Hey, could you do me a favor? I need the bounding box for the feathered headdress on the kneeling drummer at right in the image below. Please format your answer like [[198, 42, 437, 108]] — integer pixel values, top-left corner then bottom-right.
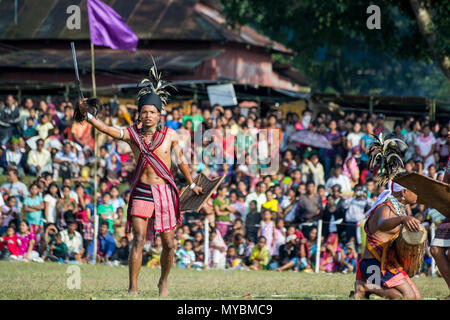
[[369, 133, 408, 185]]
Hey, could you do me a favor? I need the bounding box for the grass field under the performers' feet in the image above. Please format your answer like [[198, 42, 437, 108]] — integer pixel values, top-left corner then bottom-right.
[[0, 262, 448, 300]]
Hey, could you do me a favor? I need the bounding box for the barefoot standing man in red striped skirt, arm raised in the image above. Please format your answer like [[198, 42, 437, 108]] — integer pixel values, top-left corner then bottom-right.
[[79, 66, 202, 296]]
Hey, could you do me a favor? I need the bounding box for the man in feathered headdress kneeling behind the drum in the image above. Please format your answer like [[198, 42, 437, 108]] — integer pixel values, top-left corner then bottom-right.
[[351, 134, 421, 299]]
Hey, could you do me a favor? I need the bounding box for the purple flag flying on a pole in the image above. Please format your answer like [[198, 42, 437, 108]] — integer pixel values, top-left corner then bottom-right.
[[87, 0, 138, 51]]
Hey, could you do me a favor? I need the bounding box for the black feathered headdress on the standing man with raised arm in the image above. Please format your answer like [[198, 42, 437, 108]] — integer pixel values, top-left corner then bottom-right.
[[137, 56, 176, 112]]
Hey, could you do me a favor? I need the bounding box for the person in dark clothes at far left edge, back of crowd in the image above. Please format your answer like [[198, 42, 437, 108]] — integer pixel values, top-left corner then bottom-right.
[[0, 94, 20, 146]]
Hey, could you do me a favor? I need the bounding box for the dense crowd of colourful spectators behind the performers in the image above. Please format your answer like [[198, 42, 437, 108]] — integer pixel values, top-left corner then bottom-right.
[[0, 95, 450, 274]]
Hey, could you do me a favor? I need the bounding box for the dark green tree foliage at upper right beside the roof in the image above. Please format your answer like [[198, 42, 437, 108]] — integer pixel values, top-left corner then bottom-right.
[[221, 0, 450, 100]]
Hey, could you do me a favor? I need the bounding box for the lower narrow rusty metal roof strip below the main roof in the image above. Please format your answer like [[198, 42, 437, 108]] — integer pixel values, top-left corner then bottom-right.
[[0, 49, 222, 71]]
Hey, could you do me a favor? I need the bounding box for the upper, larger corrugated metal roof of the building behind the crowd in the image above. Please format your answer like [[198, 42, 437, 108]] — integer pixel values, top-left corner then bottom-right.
[[0, 0, 291, 53]]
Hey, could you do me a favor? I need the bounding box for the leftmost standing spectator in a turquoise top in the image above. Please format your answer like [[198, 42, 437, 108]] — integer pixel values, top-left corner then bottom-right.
[[23, 183, 45, 243]]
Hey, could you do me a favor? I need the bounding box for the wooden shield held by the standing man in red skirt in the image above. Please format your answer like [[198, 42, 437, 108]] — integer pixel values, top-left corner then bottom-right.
[[180, 173, 225, 213]]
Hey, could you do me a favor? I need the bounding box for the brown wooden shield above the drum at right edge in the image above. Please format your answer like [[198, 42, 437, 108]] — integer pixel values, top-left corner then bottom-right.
[[394, 172, 450, 218]]
